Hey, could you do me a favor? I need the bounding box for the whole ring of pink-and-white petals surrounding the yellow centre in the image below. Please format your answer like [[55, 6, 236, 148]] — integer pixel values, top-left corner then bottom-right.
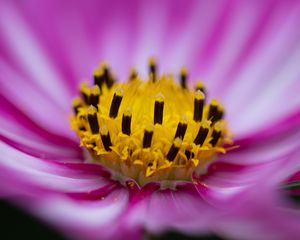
[[0, 1, 300, 239]]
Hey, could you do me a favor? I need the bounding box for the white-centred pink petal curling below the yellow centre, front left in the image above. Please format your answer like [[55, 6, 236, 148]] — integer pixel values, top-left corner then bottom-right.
[[20, 187, 131, 239]]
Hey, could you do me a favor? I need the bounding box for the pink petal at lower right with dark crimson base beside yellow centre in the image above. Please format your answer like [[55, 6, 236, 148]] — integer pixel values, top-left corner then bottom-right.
[[193, 145, 300, 209]]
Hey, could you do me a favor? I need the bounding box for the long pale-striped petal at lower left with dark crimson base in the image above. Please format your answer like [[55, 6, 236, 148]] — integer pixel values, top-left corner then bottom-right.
[[0, 142, 117, 199]]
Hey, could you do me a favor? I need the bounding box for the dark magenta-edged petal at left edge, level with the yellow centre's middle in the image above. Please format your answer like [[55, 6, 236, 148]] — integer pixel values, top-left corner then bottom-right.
[[0, 94, 81, 159]]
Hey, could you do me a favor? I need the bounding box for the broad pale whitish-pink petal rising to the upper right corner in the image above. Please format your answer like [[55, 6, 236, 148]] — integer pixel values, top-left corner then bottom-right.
[[218, 2, 300, 134]]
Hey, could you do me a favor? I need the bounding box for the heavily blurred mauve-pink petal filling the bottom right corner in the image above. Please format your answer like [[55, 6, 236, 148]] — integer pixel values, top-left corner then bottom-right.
[[214, 183, 300, 240]]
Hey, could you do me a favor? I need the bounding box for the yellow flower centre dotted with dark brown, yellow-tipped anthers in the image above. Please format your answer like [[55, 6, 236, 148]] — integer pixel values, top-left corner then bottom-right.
[[71, 59, 231, 185]]
